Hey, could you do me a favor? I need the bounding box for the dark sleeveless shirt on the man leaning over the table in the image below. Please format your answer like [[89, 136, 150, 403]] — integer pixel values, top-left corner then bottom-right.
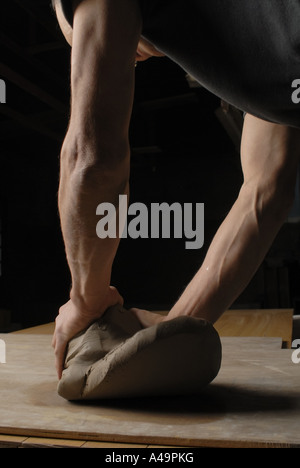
[[55, 0, 300, 127]]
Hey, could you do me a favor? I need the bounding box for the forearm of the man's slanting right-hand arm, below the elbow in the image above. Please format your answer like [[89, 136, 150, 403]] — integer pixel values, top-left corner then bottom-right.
[[170, 181, 290, 323]]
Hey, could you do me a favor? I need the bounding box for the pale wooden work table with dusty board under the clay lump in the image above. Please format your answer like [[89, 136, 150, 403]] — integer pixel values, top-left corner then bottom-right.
[[0, 310, 300, 449]]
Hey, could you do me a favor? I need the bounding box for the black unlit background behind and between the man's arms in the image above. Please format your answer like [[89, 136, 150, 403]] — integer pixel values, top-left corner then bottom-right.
[[0, 0, 300, 331]]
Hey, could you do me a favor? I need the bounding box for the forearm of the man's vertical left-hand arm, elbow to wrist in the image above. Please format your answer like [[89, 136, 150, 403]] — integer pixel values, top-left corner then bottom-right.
[[59, 140, 129, 313]]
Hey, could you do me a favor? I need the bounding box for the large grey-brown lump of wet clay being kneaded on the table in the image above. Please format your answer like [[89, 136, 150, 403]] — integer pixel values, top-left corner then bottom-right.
[[58, 306, 222, 400]]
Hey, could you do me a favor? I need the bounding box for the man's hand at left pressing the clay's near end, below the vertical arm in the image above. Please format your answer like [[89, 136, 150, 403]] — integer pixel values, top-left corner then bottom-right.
[[52, 286, 124, 379]]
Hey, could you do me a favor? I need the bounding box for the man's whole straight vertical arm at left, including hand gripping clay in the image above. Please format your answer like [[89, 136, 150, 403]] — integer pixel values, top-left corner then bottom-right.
[[53, 0, 141, 377]]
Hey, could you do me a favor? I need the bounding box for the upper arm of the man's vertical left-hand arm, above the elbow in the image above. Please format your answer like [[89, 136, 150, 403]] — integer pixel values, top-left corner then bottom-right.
[[63, 0, 142, 145]]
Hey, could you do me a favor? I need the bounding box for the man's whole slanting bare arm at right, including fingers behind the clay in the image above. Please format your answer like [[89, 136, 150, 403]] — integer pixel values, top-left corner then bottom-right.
[[135, 115, 300, 326]]
